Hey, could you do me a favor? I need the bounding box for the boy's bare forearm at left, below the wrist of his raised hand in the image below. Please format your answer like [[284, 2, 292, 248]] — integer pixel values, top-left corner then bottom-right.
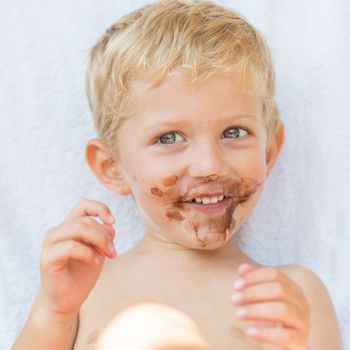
[[12, 290, 78, 350]]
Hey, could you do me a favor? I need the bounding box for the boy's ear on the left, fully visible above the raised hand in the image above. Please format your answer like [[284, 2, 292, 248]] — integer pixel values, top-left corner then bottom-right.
[[85, 139, 131, 196]]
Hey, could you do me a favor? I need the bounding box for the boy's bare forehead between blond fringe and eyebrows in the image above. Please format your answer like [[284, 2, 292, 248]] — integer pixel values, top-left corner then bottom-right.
[[123, 73, 262, 123]]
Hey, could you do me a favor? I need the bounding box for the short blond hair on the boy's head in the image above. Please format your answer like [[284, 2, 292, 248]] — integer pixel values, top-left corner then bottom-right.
[[86, 0, 279, 150]]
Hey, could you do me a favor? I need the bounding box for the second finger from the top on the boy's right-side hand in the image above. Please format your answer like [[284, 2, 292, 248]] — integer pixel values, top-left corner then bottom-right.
[[232, 282, 300, 305]]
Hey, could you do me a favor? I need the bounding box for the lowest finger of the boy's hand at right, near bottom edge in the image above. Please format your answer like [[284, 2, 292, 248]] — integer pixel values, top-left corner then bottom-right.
[[247, 327, 307, 349]]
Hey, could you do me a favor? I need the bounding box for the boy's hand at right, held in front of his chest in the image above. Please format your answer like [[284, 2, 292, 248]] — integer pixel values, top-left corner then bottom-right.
[[232, 263, 310, 350]]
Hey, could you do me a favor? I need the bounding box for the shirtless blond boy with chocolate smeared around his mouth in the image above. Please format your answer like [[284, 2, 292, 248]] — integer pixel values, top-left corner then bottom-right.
[[14, 0, 342, 350]]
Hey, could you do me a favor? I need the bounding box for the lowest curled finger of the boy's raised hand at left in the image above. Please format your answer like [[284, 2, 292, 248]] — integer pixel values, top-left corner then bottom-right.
[[41, 240, 103, 270]]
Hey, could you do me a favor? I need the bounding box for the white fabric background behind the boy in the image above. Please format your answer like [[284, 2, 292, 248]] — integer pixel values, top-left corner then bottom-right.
[[0, 0, 350, 349]]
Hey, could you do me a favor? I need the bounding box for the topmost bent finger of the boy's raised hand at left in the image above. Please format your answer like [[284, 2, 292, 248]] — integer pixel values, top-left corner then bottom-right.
[[62, 199, 115, 224]]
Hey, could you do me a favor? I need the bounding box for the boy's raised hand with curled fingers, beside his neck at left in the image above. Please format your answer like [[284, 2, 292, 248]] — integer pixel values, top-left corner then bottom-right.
[[40, 200, 116, 316]]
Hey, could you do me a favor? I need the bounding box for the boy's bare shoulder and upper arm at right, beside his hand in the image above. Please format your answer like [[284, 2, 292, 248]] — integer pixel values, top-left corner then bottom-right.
[[280, 265, 343, 350]]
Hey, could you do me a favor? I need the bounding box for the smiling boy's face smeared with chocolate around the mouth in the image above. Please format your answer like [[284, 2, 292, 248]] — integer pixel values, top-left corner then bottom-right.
[[118, 73, 267, 249]]
